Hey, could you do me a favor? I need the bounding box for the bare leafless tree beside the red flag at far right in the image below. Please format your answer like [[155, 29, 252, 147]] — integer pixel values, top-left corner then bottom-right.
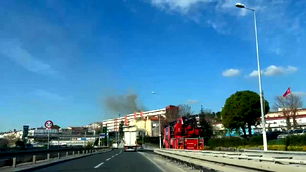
[[274, 93, 303, 130]]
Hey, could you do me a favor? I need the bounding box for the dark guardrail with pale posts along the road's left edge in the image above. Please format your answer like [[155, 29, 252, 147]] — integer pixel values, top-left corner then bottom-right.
[[0, 147, 107, 171]]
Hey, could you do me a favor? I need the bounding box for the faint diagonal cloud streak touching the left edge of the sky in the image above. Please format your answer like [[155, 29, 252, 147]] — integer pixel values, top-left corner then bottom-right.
[[0, 39, 58, 76]]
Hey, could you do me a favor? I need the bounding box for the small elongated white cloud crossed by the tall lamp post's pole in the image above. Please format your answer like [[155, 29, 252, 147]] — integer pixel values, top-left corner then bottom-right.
[[249, 65, 298, 77]]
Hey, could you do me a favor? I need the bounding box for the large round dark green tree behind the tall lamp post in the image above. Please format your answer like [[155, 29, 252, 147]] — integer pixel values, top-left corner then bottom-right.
[[221, 91, 270, 137]]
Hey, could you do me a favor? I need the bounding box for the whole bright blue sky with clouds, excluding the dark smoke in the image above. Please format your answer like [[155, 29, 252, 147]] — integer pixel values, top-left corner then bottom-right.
[[0, 0, 306, 131]]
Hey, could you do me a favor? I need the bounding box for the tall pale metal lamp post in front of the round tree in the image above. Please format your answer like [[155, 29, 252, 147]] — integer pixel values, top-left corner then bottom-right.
[[235, 3, 268, 151]]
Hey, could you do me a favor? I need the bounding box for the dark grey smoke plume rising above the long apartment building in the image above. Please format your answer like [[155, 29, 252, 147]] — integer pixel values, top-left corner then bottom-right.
[[104, 94, 144, 114]]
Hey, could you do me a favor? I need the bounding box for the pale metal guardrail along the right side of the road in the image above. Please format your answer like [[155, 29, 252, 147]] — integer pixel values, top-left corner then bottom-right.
[[154, 149, 306, 172]]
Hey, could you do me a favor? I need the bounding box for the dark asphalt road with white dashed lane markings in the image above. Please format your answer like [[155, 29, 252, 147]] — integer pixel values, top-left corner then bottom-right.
[[31, 149, 161, 172]]
